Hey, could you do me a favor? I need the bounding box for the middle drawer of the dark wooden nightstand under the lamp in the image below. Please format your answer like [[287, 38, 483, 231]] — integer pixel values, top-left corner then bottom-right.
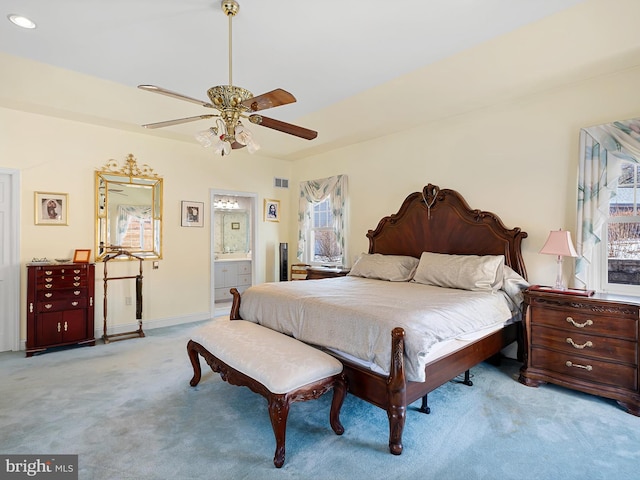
[[531, 325, 638, 365]]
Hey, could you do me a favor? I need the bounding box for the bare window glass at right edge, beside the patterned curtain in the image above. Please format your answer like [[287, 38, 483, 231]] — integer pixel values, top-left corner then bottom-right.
[[602, 162, 640, 291]]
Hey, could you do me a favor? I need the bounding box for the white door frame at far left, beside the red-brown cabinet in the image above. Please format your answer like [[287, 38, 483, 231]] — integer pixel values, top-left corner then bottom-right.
[[0, 167, 20, 351]]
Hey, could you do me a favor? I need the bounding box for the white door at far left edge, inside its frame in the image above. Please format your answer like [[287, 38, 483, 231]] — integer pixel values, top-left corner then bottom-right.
[[0, 170, 20, 352]]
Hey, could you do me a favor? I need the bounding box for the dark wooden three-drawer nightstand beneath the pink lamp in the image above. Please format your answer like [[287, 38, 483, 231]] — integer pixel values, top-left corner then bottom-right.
[[519, 287, 640, 416]]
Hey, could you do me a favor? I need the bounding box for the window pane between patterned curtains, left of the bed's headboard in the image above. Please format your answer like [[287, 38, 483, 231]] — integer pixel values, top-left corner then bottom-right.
[[309, 197, 342, 265]]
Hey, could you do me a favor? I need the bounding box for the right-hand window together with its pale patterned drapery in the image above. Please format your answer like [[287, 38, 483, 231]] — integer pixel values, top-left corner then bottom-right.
[[575, 118, 640, 295]]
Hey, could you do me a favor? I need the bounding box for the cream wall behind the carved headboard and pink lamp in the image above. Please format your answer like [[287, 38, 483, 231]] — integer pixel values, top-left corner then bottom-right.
[[289, 67, 640, 284]]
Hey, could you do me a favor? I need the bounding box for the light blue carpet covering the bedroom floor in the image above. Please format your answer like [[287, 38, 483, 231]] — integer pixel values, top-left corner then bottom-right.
[[0, 318, 640, 480]]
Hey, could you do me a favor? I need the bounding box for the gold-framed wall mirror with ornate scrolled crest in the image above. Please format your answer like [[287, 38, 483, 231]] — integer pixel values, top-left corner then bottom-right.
[[95, 154, 162, 261]]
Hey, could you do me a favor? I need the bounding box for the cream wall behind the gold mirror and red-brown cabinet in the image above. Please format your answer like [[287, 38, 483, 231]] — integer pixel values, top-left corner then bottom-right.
[[0, 108, 291, 342]]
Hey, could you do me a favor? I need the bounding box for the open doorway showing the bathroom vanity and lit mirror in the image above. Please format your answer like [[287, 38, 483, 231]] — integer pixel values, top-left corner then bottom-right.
[[210, 189, 258, 316]]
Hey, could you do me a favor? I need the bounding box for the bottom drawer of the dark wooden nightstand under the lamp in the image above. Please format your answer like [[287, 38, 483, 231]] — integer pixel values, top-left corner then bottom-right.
[[531, 348, 638, 390]]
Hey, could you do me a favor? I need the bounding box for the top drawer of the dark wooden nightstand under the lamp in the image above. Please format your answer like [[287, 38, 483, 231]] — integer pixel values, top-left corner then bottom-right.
[[531, 304, 638, 340]]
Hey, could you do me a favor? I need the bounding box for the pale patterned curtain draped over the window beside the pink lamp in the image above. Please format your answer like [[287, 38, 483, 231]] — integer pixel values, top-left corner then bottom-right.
[[575, 118, 640, 288]]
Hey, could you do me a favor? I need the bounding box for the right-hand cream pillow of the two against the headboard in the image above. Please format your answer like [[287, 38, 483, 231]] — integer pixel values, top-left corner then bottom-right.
[[413, 252, 504, 291]]
